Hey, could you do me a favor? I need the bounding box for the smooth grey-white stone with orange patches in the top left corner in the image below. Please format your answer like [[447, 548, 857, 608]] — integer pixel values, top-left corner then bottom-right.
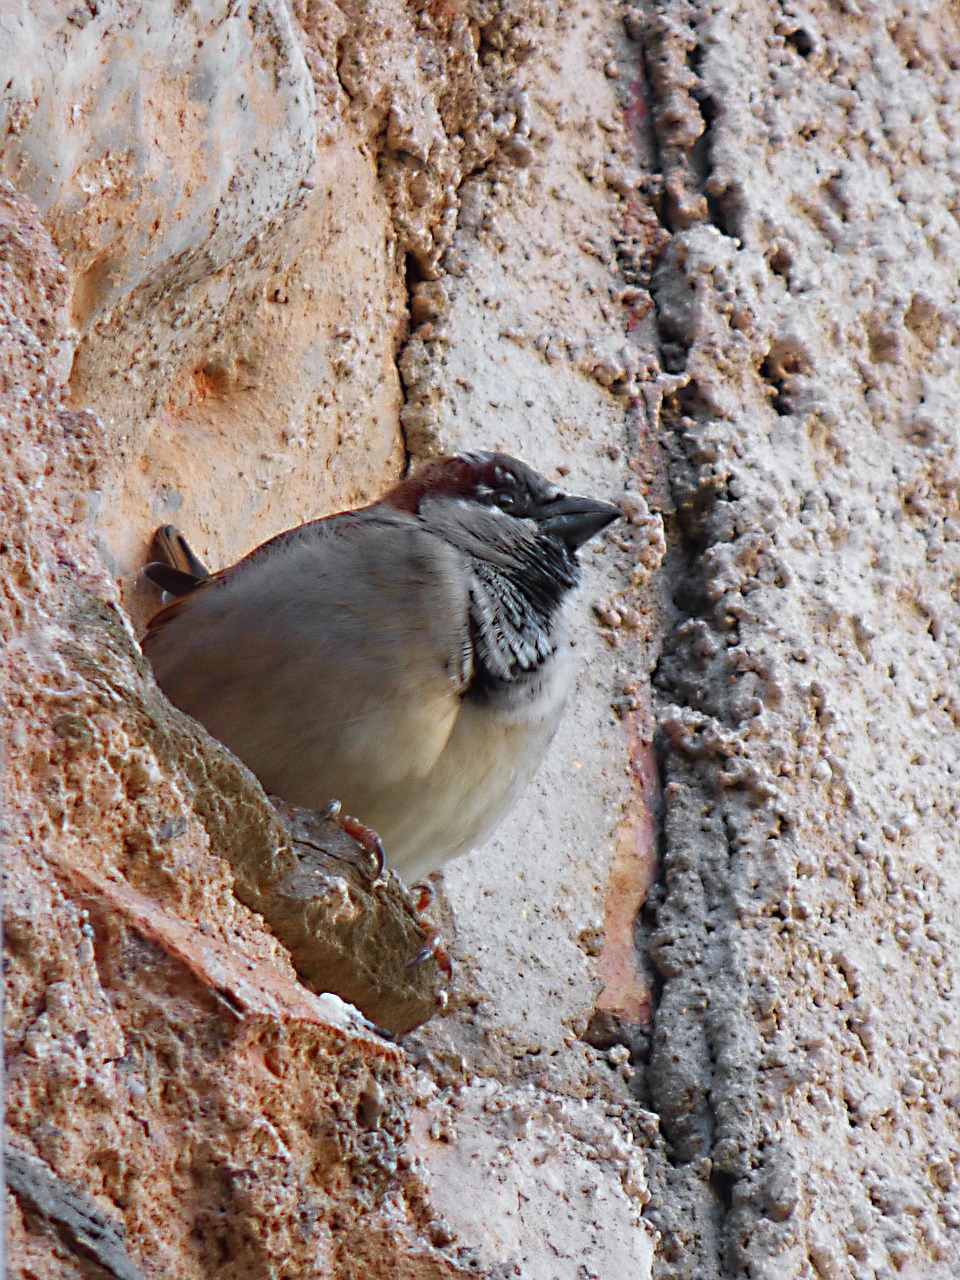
[[0, 0, 316, 329]]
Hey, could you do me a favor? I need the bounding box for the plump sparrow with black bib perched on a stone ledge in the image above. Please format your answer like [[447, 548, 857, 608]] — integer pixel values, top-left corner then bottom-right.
[[143, 453, 622, 884]]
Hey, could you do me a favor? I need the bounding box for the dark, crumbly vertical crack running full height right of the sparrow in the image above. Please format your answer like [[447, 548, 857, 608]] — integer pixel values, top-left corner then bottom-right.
[[635, 5, 777, 1280]]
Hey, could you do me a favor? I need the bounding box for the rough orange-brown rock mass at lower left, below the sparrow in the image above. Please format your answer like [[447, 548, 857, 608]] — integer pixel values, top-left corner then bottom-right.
[[0, 177, 456, 1276]]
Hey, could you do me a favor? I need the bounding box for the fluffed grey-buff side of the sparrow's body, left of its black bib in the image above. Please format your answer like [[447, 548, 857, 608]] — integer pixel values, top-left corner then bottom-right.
[[143, 512, 472, 804]]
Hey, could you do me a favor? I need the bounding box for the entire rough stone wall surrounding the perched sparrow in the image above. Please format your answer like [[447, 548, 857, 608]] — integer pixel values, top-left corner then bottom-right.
[[0, 0, 960, 1280]]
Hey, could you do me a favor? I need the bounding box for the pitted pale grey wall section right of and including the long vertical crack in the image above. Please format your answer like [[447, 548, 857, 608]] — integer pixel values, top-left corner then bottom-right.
[[640, 3, 960, 1280]]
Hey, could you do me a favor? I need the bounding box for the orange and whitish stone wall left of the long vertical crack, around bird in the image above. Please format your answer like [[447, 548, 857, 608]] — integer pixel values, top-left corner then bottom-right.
[[0, 0, 663, 1280]]
